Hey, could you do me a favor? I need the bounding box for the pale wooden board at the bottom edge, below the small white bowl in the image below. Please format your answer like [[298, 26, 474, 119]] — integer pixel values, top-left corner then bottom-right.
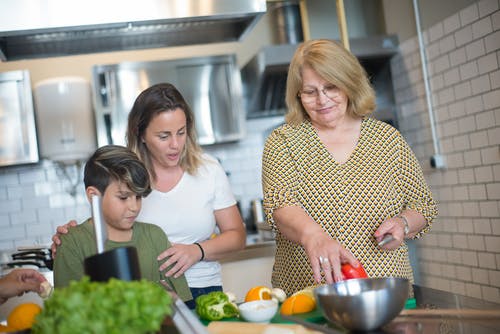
[[207, 321, 319, 334]]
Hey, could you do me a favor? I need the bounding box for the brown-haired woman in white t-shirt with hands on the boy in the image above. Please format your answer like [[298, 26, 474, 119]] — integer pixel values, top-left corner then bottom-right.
[[52, 83, 246, 307]]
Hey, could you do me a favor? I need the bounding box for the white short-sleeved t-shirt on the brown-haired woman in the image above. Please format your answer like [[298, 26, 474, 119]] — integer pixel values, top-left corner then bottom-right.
[[137, 154, 236, 288]]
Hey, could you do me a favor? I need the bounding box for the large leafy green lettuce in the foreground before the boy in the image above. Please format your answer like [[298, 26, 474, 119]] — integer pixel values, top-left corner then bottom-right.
[[31, 277, 172, 334]]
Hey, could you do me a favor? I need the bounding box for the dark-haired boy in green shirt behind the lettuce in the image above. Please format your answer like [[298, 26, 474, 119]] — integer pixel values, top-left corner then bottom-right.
[[54, 145, 192, 301]]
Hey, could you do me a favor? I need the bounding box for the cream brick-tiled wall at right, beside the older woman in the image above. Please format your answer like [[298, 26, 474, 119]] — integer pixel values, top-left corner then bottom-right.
[[392, 0, 500, 303]]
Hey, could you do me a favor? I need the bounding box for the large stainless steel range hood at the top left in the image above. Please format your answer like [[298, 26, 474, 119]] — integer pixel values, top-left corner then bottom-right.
[[0, 0, 266, 61]]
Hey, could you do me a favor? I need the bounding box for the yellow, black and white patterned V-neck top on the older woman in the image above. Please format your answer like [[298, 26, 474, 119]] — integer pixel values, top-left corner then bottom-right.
[[262, 117, 437, 295]]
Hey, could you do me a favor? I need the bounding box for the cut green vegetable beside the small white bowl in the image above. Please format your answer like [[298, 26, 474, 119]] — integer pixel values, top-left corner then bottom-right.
[[195, 291, 239, 321]]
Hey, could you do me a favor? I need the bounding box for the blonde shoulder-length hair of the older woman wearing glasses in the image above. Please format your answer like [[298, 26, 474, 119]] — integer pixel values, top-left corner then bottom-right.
[[285, 39, 376, 125]]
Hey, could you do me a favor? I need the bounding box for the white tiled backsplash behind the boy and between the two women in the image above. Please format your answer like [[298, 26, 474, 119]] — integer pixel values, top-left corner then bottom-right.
[[0, 117, 283, 249]]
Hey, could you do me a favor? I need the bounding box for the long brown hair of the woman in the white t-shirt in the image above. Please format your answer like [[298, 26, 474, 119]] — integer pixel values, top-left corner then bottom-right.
[[127, 83, 202, 180]]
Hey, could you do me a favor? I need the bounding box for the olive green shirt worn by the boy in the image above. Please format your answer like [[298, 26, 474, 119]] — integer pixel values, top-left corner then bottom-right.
[[54, 219, 192, 301]]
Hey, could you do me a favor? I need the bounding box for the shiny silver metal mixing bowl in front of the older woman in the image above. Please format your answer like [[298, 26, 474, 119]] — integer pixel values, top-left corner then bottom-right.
[[314, 277, 410, 331]]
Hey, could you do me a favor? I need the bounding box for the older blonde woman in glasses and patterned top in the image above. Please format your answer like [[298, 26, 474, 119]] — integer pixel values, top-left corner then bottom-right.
[[262, 40, 437, 294]]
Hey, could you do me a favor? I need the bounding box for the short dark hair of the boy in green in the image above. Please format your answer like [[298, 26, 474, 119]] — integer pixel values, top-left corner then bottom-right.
[[83, 145, 151, 197]]
